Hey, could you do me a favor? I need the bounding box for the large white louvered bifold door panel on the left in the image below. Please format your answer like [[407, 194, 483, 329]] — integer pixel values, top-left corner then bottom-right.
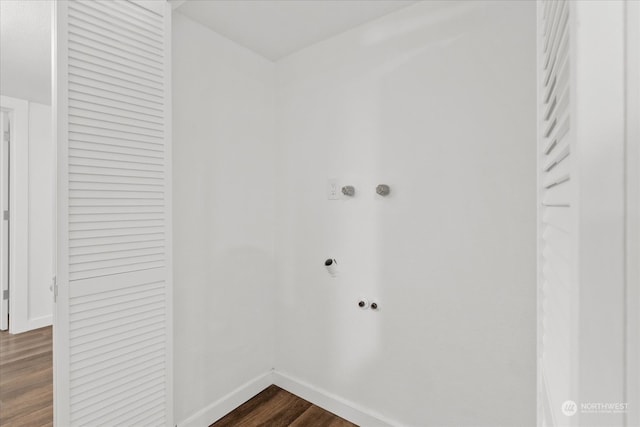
[[54, 0, 173, 426]]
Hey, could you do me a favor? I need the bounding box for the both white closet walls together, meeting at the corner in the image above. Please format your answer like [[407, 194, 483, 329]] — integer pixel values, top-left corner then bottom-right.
[[173, 2, 536, 426]]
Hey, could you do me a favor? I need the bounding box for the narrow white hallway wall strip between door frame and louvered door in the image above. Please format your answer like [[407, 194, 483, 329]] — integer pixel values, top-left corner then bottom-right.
[[28, 102, 55, 327]]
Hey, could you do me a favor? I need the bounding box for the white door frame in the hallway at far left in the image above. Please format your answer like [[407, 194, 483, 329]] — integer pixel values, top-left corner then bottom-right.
[[0, 96, 30, 334]]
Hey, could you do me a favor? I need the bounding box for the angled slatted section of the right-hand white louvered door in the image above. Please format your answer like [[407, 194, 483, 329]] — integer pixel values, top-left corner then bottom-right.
[[538, 0, 575, 424]]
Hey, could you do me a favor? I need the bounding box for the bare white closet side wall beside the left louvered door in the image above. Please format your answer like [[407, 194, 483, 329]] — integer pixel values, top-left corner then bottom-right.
[[173, 12, 275, 423]]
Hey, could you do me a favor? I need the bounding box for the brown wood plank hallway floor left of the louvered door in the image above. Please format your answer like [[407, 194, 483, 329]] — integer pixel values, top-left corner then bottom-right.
[[0, 327, 53, 427]]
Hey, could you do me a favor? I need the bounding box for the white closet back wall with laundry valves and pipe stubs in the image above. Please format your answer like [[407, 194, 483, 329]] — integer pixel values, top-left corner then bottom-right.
[[275, 1, 536, 426]]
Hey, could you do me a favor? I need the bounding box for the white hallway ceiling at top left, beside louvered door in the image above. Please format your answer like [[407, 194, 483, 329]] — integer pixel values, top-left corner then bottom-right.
[[0, 0, 51, 104]]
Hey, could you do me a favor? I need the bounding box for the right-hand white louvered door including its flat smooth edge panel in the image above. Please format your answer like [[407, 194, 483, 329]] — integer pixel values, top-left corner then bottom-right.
[[537, 0, 633, 427]]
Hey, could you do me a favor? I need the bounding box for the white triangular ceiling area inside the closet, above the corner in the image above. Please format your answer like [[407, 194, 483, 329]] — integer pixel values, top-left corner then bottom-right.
[[172, 0, 417, 61]]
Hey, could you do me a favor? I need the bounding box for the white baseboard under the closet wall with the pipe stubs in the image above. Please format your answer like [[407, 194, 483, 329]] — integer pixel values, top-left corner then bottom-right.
[[273, 371, 402, 427]]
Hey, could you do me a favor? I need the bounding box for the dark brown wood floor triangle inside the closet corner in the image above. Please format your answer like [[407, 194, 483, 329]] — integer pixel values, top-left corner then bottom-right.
[[209, 385, 357, 427]]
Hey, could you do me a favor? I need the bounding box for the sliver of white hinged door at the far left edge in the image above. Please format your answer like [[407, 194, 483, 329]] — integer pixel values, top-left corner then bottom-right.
[[0, 111, 11, 331]]
